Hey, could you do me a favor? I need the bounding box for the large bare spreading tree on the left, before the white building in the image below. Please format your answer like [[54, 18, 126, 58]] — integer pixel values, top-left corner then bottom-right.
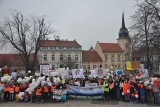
[[0, 12, 52, 73]]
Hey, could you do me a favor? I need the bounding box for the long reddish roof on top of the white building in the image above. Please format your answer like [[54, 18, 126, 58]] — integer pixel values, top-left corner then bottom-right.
[[42, 40, 81, 47]]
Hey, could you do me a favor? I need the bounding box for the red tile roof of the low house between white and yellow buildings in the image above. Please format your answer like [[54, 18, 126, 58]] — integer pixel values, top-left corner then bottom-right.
[[82, 50, 102, 62]]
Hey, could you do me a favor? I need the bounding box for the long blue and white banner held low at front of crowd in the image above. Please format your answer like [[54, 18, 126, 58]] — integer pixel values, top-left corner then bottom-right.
[[67, 85, 104, 95]]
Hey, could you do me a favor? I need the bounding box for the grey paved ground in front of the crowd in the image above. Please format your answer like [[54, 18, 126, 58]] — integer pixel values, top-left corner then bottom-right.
[[0, 99, 160, 107]]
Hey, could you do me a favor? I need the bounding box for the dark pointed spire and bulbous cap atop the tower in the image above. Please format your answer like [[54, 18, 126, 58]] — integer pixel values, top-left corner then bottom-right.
[[119, 12, 129, 38]]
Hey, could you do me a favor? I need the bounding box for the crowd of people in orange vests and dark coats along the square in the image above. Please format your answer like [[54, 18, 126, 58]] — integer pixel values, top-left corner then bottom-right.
[[0, 70, 160, 104]]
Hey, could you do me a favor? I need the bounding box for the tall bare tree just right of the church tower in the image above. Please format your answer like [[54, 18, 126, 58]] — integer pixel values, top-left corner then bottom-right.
[[131, 2, 155, 69]]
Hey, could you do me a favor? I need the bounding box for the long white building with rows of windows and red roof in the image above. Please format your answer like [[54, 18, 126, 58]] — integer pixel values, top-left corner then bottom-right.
[[38, 40, 82, 70]]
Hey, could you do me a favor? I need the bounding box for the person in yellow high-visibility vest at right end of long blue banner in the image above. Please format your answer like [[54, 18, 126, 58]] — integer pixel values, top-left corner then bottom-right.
[[103, 78, 109, 101]]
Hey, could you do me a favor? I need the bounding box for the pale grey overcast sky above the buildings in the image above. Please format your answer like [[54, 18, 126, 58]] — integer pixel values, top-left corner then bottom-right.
[[0, 0, 136, 50]]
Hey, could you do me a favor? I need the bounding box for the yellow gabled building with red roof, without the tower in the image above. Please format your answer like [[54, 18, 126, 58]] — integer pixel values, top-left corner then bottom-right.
[[95, 42, 123, 69]]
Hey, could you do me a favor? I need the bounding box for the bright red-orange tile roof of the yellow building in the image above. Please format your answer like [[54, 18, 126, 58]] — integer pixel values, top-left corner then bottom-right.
[[99, 43, 123, 52]]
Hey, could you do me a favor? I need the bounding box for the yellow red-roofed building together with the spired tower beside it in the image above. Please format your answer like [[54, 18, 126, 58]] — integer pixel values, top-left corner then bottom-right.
[[95, 13, 131, 70]]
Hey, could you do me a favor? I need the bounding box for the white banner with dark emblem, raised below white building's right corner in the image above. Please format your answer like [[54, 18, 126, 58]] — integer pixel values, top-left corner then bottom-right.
[[72, 69, 84, 78]]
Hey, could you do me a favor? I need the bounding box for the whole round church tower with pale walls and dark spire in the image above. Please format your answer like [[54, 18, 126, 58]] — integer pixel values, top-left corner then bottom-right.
[[117, 12, 131, 60]]
